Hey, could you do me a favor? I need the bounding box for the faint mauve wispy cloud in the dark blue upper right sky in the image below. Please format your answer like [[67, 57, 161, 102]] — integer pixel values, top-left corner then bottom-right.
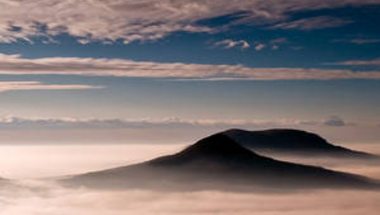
[[271, 16, 352, 30]]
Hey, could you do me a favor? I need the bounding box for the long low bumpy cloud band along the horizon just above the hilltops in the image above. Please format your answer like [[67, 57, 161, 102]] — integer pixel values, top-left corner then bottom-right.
[[0, 116, 360, 129]]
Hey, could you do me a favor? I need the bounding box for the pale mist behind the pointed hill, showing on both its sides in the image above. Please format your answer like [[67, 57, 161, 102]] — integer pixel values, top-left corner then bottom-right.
[[0, 141, 380, 179]]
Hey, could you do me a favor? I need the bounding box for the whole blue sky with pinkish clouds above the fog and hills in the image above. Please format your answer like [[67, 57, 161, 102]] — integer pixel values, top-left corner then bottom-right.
[[0, 0, 380, 144]]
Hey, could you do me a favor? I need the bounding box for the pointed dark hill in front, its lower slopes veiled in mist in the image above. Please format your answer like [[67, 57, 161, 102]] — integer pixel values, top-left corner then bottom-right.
[[64, 133, 379, 191]]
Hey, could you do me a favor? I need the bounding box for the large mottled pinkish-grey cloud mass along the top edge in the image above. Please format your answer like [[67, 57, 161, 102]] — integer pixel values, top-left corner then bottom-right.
[[0, 0, 380, 43]]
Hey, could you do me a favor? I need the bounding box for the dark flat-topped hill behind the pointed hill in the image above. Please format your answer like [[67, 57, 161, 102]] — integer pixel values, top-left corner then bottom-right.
[[222, 129, 380, 160]]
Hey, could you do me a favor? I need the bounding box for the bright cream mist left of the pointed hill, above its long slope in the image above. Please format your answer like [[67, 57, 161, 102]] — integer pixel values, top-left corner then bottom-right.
[[0, 144, 185, 179]]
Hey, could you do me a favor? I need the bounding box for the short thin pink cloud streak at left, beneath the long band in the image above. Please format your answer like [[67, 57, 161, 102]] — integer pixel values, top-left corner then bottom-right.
[[0, 81, 102, 93]]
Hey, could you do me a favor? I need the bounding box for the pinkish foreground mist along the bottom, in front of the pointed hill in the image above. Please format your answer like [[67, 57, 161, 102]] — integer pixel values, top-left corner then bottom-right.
[[0, 182, 380, 215]]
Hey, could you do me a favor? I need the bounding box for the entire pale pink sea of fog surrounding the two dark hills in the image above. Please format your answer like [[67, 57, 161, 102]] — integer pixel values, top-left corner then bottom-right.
[[0, 144, 380, 215]]
